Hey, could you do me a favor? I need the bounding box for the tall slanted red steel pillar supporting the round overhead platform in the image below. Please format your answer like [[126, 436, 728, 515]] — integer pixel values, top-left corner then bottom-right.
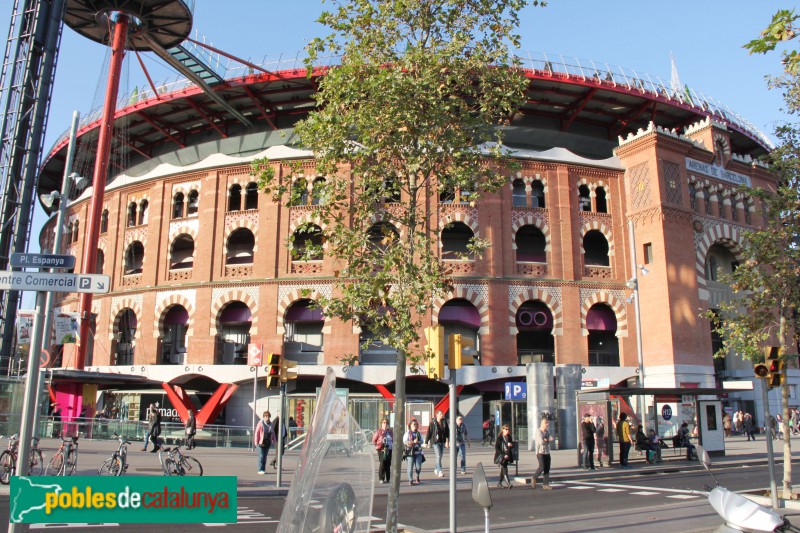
[[75, 13, 129, 370]]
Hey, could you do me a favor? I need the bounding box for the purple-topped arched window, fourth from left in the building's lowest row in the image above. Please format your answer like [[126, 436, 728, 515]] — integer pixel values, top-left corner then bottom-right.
[[283, 299, 325, 365]]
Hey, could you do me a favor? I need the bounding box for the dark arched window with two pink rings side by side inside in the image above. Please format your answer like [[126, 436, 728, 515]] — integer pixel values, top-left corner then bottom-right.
[[516, 300, 556, 365]]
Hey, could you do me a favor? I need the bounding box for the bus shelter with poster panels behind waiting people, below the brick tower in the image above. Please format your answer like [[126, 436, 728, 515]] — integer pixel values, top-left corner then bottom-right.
[[575, 387, 727, 464]]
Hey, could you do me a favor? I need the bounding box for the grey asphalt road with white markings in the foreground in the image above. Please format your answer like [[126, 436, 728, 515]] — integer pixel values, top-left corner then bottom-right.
[[0, 465, 788, 533]]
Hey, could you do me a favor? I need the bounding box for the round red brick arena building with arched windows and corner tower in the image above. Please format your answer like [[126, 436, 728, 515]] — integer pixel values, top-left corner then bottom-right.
[[40, 58, 774, 432]]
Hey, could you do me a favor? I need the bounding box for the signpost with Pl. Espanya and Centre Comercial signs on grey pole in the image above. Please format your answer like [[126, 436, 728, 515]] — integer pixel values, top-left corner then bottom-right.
[[10, 254, 111, 494]]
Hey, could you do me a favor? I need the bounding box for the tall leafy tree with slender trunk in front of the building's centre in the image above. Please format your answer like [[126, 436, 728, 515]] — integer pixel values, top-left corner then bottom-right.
[[254, 0, 540, 531]]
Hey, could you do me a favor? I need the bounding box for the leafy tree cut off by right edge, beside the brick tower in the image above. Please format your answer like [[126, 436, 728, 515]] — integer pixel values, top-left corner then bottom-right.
[[707, 10, 800, 497]]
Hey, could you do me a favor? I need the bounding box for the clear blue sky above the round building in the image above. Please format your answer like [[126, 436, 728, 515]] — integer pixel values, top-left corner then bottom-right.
[[0, 0, 787, 264]]
